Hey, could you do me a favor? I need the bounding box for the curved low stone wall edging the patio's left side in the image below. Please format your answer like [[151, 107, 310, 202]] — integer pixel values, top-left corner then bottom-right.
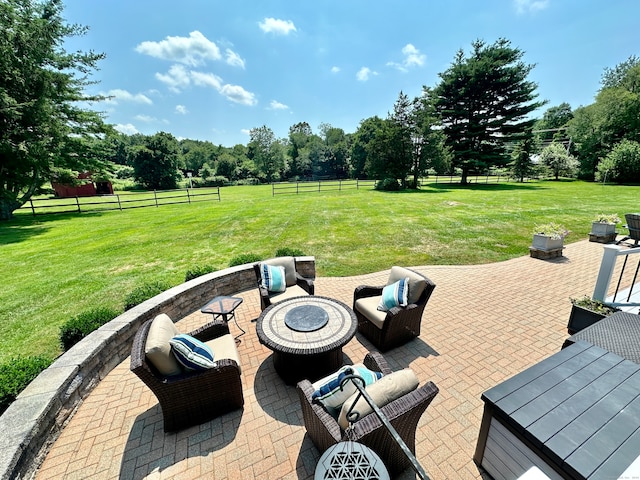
[[0, 257, 316, 480]]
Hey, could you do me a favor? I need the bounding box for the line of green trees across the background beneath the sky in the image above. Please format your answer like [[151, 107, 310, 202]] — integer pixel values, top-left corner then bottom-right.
[[0, 0, 640, 219]]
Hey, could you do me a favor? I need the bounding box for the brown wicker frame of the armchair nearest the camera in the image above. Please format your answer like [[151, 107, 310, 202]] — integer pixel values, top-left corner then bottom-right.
[[297, 352, 438, 477]]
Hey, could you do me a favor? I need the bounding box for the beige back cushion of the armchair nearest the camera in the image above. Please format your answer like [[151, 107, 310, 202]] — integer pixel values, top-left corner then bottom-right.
[[338, 368, 418, 430]]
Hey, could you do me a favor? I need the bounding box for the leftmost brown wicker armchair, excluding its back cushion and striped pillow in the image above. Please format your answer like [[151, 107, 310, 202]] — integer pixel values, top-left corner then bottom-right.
[[131, 317, 244, 432]]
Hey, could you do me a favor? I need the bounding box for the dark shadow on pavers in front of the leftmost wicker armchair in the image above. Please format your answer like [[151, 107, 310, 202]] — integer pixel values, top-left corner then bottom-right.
[[118, 404, 244, 480]]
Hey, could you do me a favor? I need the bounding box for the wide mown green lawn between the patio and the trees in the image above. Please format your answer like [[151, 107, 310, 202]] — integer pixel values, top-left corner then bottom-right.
[[0, 181, 639, 362]]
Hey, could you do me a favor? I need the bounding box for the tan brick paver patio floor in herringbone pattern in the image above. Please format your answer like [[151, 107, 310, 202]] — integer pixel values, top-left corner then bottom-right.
[[37, 241, 624, 480]]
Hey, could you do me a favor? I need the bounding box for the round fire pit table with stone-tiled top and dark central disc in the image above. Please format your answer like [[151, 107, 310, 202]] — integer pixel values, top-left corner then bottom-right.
[[256, 295, 358, 385]]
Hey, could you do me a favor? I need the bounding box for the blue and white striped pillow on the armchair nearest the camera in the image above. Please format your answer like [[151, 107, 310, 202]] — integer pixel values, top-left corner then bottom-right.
[[311, 363, 382, 409]]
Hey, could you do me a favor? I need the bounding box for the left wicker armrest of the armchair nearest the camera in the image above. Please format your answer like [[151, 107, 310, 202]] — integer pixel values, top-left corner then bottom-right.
[[296, 380, 342, 451]]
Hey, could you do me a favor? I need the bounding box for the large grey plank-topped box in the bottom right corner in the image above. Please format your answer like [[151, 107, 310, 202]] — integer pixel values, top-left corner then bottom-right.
[[473, 342, 640, 480]]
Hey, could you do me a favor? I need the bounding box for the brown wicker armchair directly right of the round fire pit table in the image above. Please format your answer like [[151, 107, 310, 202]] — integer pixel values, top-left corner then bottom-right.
[[353, 267, 436, 352]]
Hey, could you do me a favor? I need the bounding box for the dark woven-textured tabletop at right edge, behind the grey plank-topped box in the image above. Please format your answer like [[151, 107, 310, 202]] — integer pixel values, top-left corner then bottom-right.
[[562, 312, 640, 364]]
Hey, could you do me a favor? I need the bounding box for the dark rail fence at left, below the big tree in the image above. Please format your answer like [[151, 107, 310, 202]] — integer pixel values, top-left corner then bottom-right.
[[20, 187, 220, 216]]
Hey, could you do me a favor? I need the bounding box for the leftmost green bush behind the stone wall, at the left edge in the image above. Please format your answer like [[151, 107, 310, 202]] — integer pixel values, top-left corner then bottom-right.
[[0, 356, 51, 415]]
